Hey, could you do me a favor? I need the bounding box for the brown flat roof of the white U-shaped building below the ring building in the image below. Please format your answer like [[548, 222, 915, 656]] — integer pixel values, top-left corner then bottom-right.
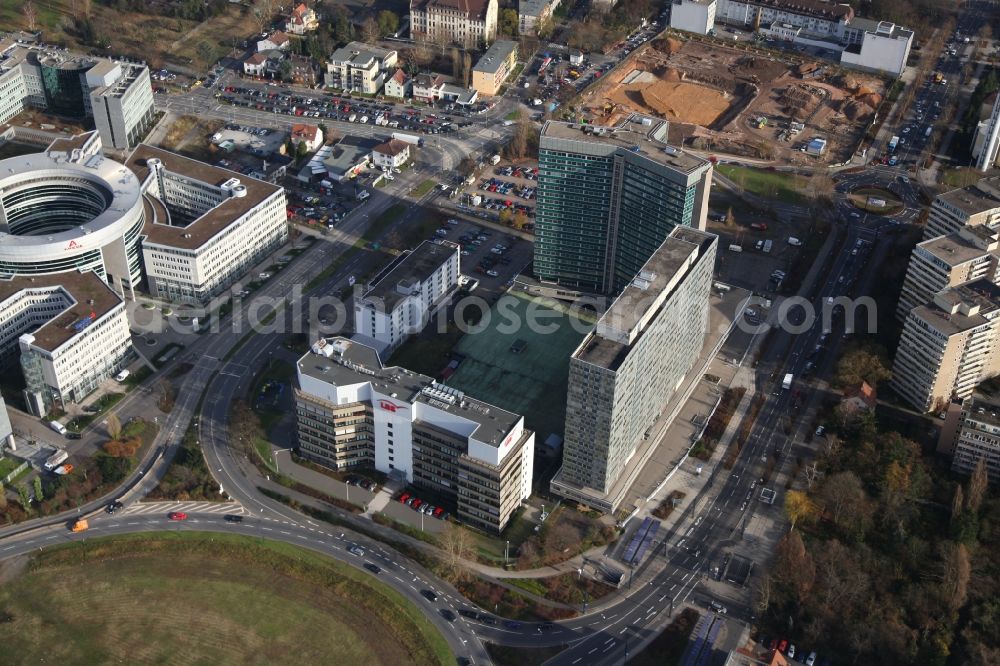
[[0, 272, 122, 352]]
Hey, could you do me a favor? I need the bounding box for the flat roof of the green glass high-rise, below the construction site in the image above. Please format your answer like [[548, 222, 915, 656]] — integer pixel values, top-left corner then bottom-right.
[[541, 119, 709, 174]]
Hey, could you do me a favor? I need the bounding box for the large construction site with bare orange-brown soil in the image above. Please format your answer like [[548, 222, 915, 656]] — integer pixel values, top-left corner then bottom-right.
[[577, 37, 886, 164]]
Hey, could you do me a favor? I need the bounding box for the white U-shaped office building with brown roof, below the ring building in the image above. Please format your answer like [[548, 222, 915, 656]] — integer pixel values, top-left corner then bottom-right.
[[10, 272, 133, 416]]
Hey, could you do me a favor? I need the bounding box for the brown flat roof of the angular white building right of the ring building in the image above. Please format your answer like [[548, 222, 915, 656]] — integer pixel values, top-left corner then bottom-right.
[[125, 143, 282, 250]]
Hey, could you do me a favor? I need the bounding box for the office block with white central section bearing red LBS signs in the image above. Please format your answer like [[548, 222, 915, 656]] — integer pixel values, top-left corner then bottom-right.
[[295, 338, 535, 532]]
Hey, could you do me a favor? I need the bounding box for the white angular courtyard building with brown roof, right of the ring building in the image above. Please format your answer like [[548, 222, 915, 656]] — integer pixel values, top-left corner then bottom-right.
[[126, 144, 288, 303]]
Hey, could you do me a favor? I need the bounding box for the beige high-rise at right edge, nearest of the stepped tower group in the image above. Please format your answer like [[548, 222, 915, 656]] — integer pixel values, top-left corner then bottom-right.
[[892, 280, 1000, 412]]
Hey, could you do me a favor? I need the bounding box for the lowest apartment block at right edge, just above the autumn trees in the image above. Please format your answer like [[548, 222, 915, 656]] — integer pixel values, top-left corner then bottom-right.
[[938, 395, 1000, 483]]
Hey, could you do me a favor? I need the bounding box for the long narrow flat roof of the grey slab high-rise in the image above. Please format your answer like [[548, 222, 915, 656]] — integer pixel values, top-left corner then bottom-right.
[[574, 227, 716, 370]]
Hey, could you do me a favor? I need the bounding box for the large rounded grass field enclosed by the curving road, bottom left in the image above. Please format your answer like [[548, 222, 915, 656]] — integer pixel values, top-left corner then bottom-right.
[[0, 532, 454, 664]]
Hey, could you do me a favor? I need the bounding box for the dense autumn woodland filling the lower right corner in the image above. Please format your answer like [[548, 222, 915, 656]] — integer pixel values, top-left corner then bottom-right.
[[755, 404, 1000, 666]]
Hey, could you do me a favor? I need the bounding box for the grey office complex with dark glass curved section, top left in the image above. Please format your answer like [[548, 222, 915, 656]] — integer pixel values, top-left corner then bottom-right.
[[0, 43, 154, 150]]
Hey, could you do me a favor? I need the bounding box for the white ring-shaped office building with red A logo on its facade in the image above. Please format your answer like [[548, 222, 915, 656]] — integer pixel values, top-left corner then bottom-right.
[[0, 132, 145, 297]]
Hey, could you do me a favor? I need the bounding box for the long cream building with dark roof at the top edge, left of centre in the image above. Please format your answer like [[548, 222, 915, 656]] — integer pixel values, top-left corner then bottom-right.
[[410, 0, 498, 49]]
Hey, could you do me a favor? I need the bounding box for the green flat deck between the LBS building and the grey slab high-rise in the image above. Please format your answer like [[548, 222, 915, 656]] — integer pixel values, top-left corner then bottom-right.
[[447, 292, 596, 443]]
